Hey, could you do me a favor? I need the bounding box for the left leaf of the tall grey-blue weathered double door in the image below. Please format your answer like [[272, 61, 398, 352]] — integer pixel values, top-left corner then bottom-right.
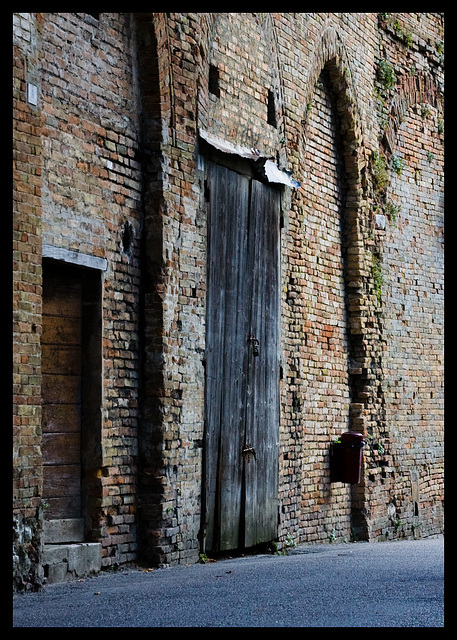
[[205, 163, 249, 549]]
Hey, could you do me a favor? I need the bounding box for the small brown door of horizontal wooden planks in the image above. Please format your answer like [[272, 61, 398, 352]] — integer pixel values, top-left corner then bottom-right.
[[42, 265, 82, 520]]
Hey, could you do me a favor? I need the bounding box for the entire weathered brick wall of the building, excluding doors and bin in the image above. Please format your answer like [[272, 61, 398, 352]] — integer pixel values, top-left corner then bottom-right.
[[14, 13, 444, 583]]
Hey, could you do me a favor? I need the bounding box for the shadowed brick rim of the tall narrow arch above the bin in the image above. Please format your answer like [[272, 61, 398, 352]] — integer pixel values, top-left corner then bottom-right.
[[302, 26, 379, 539]]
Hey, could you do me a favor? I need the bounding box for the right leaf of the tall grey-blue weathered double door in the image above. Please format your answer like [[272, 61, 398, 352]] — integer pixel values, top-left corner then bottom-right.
[[244, 181, 280, 547]]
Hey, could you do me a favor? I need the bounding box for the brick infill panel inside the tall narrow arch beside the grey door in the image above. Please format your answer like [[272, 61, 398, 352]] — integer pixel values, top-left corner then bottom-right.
[[285, 66, 352, 539]]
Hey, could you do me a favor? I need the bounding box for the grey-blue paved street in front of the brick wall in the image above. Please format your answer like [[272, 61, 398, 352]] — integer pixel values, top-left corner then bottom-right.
[[13, 536, 444, 627]]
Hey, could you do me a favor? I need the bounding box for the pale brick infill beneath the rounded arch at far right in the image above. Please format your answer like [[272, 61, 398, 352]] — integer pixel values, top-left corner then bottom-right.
[[383, 103, 444, 534]]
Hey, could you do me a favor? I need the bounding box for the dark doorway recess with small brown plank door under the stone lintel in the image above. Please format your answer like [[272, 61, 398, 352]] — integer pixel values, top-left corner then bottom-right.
[[42, 260, 102, 543]]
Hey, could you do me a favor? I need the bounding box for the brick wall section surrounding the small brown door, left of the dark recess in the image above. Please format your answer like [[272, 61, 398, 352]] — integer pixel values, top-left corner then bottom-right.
[[15, 14, 142, 584]]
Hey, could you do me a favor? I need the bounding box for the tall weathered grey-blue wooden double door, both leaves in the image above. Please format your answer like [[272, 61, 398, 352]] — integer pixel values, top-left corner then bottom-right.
[[205, 162, 280, 551]]
